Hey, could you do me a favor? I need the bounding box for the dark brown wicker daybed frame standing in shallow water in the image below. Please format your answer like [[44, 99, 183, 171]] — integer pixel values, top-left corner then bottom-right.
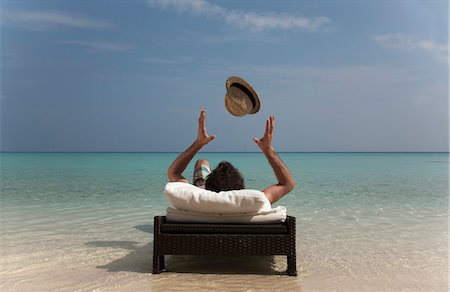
[[153, 216, 297, 276]]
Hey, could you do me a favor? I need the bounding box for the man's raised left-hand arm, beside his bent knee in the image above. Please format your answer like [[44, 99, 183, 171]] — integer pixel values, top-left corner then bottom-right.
[[167, 110, 216, 183]]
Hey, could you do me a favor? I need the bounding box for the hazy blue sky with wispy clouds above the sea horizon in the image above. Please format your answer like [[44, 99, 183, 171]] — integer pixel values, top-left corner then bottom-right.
[[0, 0, 449, 152]]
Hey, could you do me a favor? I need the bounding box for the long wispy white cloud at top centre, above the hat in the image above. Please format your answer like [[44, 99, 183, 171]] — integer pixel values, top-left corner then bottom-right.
[[147, 0, 332, 31]]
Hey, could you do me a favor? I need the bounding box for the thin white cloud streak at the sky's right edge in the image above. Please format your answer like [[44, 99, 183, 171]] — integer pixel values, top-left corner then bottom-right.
[[373, 33, 448, 62]]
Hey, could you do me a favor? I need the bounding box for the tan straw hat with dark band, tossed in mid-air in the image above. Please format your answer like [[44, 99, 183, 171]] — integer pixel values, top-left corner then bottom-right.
[[225, 76, 260, 117]]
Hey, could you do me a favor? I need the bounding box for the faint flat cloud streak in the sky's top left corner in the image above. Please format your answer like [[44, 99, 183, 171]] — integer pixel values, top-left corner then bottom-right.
[[2, 10, 114, 30]]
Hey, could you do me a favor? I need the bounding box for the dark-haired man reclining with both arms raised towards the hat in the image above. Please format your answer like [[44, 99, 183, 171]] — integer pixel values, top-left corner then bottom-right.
[[167, 110, 295, 203]]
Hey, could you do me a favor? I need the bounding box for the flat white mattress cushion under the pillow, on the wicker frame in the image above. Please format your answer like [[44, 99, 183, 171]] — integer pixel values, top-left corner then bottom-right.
[[166, 206, 286, 223]]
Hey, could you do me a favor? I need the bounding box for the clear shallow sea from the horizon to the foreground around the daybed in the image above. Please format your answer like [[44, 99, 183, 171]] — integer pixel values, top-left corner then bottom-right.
[[0, 153, 449, 291]]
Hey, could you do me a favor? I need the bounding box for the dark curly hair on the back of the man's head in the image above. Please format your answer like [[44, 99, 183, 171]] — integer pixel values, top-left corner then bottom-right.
[[205, 161, 245, 192]]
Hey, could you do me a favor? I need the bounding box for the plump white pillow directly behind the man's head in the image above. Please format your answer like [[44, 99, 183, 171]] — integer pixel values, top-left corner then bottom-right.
[[164, 182, 271, 214]]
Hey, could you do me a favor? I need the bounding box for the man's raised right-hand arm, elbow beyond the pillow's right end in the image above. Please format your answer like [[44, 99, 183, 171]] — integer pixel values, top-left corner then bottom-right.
[[253, 115, 295, 203]]
